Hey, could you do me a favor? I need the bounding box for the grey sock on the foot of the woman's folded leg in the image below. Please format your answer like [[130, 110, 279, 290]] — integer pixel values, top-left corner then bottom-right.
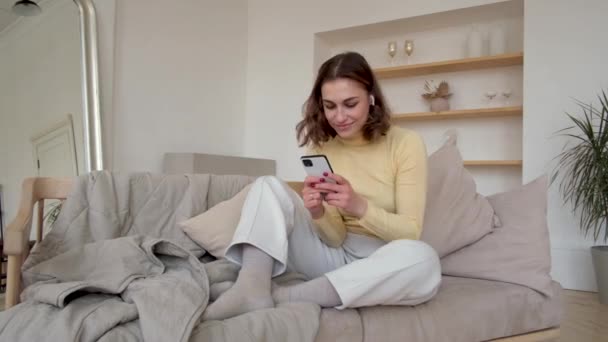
[[272, 276, 342, 308]]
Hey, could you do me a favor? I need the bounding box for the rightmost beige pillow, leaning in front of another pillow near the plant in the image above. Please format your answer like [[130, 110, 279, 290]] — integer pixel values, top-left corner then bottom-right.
[[441, 176, 553, 296]]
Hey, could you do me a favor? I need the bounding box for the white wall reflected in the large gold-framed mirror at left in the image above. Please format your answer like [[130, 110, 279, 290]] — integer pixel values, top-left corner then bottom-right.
[[0, 0, 84, 234]]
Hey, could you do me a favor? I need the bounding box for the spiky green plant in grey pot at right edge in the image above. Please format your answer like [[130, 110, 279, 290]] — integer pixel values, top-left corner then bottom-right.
[[552, 91, 608, 304]]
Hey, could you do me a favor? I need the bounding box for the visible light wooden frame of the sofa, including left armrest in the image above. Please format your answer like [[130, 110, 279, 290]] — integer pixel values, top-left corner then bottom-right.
[[4, 178, 560, 342]]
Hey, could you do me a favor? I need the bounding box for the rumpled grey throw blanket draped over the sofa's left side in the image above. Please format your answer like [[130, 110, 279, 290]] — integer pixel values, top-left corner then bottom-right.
[[0, 172, 320, 342]]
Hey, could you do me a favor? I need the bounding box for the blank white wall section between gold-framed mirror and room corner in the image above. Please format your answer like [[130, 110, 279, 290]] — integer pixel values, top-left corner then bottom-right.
[[107, 0, 247, 172]]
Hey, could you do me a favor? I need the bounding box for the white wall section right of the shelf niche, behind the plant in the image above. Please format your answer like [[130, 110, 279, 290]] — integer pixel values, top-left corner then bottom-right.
[[523, 0, 608, 290]]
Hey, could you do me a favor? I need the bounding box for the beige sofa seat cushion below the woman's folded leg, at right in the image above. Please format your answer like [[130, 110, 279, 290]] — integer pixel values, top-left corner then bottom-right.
[[346, 276, 561, 342]]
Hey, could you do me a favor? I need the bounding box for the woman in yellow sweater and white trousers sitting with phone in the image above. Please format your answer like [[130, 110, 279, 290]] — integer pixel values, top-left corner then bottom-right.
[[205, 52, 441, 319]]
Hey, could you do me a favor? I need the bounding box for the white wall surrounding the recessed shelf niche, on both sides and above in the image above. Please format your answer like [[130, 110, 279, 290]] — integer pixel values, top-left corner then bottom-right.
[[244, 0, 608, 289]]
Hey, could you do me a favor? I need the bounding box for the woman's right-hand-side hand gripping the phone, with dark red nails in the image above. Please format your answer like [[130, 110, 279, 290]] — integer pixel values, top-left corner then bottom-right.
[[315, 173, 367, 218]]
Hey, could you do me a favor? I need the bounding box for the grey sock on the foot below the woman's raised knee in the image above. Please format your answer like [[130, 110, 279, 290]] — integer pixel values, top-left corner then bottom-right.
[[203, 245, 274, 320]]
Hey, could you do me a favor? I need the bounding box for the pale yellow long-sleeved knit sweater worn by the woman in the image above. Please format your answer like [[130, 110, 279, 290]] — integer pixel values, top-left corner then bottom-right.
[[311, 126, 427, 247]]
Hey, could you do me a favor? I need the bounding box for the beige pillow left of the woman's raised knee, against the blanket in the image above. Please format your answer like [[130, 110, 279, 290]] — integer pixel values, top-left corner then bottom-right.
[[179, 184, 251, 258]]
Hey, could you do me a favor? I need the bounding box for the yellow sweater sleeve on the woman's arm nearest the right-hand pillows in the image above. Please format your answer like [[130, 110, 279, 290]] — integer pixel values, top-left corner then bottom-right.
[[359, 134, 427, 241]]
